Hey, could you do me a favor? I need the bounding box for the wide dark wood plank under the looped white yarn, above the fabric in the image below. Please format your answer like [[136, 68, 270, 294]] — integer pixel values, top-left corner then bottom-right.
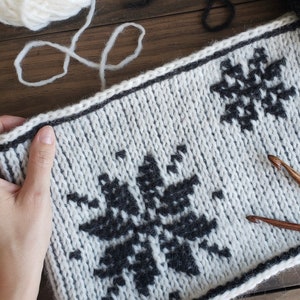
[[0, 0, 286, 117]]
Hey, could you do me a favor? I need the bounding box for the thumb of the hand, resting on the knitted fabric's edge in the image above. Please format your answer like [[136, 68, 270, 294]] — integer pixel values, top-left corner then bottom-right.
[[22, 126, 55, 198]]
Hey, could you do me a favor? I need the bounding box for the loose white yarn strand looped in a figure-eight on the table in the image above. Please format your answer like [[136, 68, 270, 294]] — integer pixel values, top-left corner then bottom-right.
[[14, 0, 146, 90]]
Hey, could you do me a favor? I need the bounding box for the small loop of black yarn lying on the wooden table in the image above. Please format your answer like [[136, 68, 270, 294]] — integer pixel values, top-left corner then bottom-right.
[[202, 0, 235, 32]]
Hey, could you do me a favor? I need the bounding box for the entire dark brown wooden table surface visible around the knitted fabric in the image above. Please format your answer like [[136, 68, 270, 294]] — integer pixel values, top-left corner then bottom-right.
[[0, 0, 300, 300]]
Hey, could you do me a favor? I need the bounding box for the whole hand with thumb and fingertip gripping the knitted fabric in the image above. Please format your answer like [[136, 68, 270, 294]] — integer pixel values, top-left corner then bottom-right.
[[0, 116, 55, 300]]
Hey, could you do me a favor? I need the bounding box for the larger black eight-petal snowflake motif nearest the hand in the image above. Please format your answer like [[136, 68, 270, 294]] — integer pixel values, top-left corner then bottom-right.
[[67, 145, 231, 299]]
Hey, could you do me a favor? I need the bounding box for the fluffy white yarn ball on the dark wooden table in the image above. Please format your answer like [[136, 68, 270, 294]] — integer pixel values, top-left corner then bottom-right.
[[0, 0, 91, 30]]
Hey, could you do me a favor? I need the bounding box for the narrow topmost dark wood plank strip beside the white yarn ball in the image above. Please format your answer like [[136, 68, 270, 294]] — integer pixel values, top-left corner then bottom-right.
[[0, 0, 257, 41]]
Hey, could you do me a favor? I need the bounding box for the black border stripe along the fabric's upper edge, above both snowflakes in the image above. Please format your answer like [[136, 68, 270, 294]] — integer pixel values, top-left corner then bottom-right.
[[0, 21, 300, 152]]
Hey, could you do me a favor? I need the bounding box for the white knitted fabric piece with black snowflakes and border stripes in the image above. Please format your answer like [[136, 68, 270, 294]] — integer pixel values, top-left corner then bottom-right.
[[0, 12, 300, 300]]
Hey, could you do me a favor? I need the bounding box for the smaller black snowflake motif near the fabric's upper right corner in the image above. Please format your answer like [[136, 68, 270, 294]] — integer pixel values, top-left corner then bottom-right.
[[210, 48, 295, 130]]
